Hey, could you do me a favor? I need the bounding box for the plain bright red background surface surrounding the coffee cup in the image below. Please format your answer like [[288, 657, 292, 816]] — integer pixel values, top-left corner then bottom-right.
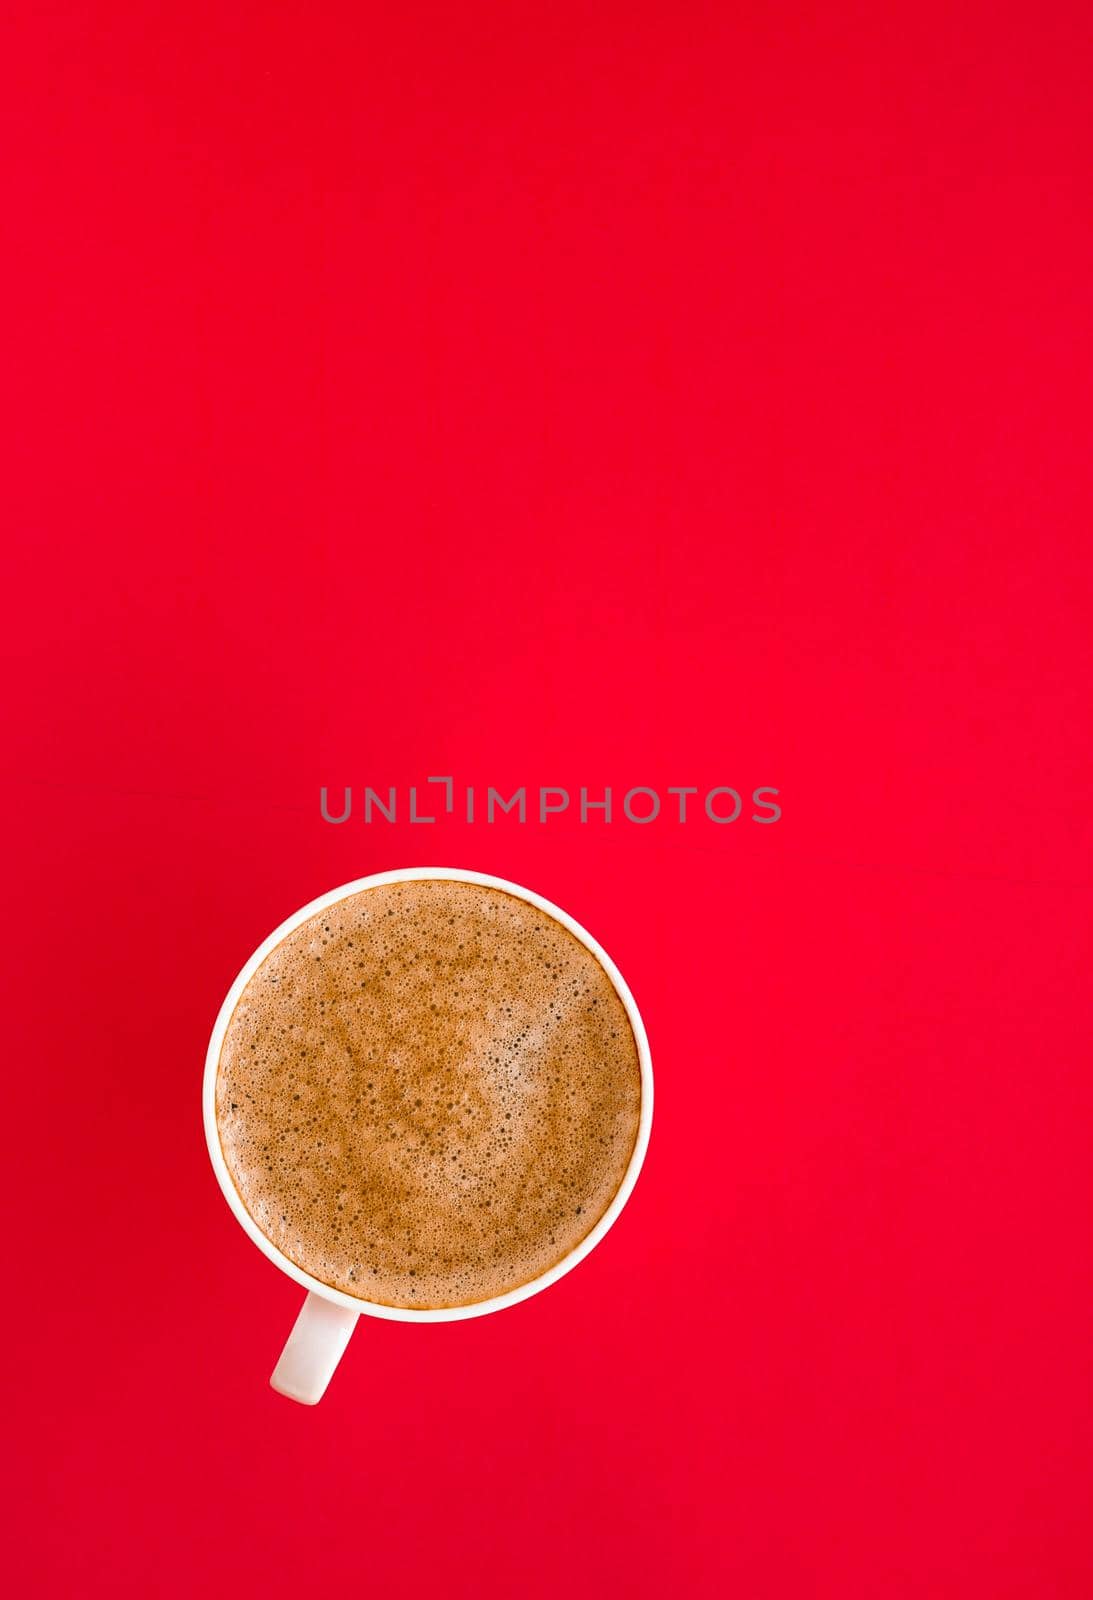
[[3, 0, 1093, 1600]]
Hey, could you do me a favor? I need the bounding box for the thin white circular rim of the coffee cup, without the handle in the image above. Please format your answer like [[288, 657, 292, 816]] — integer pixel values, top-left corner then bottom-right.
[[202, 867, 653, 1322]]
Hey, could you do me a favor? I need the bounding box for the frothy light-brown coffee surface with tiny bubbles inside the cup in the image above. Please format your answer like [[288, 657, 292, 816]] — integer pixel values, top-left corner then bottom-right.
[[216, 878, 642, 1309]]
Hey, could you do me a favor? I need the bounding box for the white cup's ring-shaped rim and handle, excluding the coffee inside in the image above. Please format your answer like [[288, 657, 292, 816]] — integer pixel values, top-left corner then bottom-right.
[[202, 867, 653, 1405]]
